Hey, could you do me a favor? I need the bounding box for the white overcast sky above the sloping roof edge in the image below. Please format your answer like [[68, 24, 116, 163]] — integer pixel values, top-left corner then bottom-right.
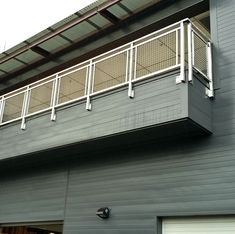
[[0, 0, 94, 53]]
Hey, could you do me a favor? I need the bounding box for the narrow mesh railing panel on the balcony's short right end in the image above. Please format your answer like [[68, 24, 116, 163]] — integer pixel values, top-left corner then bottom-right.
[[193, 33, 208, 76]]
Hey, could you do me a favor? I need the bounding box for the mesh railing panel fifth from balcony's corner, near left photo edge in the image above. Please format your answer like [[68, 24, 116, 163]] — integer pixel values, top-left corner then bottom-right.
[[3, 93, 24, 122]]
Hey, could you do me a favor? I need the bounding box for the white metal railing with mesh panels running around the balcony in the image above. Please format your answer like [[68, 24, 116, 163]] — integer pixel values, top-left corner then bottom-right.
[[0, 19, 213, 129]]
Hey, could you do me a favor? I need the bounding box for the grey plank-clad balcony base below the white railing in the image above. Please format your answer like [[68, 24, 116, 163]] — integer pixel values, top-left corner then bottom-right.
[[0, 70, 212, 159]]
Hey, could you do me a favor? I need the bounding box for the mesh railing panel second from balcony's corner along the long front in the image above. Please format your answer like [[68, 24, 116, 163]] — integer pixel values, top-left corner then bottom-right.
[[93, 52, 127, 92]]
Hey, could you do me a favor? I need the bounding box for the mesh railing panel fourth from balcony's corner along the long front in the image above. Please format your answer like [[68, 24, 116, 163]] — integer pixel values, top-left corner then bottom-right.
[[28, 82, 53, 114]]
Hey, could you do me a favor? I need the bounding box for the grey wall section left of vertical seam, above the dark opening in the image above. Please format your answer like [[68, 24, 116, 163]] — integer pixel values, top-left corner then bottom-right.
[[0, 159, 67, 224]]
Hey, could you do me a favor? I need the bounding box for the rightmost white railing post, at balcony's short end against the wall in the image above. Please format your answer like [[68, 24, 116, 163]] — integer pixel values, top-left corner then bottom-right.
[[206, 42, 214, 97]]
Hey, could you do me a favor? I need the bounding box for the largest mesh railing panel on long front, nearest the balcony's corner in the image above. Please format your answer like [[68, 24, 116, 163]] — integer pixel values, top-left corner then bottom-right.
[[135, 31, 177, 78]]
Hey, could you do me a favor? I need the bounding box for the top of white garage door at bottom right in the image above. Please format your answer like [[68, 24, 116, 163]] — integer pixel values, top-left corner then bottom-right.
[[162, 217, 235, 234]]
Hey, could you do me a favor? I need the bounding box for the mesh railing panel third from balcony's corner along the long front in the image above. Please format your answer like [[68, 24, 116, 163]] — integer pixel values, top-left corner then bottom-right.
[[59, 68, 87, 103]]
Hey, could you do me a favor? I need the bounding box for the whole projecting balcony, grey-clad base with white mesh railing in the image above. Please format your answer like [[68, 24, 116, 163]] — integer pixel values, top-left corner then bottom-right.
[[0, 19, 214, 157]]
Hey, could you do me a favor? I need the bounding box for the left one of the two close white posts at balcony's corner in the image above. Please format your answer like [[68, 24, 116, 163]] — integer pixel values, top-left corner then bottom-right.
[[176, 21, 185, 84]]
